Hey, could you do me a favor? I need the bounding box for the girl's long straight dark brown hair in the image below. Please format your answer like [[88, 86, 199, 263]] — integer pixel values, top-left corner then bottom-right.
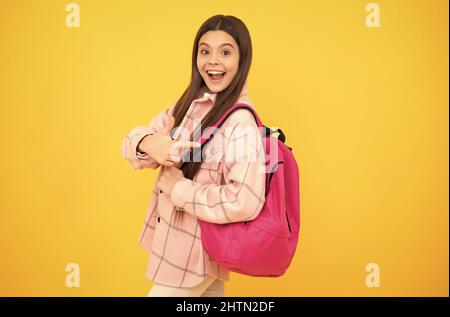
[[173, 15, 252, 222]]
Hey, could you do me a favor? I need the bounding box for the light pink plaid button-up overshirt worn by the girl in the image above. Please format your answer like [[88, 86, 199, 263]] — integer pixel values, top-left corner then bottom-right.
[[122, 85, 265, 287]]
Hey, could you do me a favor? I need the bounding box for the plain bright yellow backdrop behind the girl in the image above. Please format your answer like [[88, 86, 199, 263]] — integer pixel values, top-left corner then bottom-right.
[[0, 0, 449, 296]]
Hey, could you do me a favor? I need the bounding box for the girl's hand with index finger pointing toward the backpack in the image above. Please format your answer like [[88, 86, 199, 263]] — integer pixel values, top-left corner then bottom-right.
[[139, 116, 200, 167]]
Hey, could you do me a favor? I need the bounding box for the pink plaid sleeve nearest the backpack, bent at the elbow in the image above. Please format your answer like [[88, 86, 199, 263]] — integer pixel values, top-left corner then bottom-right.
[[171, 109, 266, 224]]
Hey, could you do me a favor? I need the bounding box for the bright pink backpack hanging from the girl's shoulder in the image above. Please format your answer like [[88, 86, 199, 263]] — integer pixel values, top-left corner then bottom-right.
[[181, 103, 300, 277]]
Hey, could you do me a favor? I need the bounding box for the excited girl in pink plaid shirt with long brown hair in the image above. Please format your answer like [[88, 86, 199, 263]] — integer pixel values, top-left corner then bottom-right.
[[122, 15, 265, 296]]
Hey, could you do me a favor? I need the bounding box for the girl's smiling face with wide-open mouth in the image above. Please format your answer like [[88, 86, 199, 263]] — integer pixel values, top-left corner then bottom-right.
[[197, 30, 239, 93]]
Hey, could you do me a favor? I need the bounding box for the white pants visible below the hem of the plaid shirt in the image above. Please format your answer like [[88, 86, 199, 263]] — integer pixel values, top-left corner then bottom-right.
[[147, 276, 225, 297]]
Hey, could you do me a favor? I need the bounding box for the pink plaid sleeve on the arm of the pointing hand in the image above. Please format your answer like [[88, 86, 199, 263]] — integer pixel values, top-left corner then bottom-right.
[[121, 104, 175, 170]]
